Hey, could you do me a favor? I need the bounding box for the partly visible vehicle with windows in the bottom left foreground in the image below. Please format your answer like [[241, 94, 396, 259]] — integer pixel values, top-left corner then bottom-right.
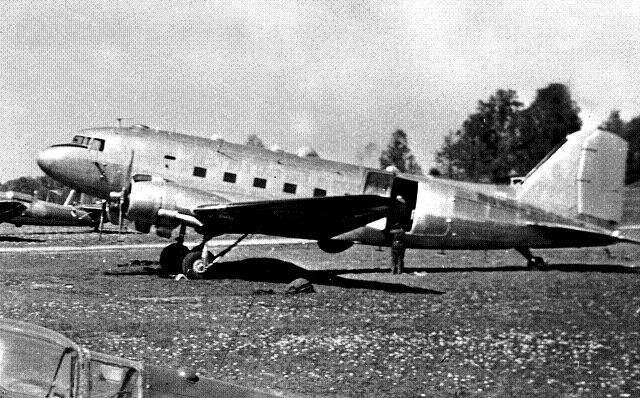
[[0, 319, 282, 398]]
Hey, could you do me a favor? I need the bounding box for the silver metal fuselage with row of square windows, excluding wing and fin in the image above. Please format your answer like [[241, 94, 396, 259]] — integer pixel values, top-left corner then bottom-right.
[[38, 126, 615, 249]]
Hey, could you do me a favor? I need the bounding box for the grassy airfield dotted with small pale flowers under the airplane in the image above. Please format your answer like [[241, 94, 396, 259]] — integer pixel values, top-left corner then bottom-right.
[[0, 226, 640, 397]]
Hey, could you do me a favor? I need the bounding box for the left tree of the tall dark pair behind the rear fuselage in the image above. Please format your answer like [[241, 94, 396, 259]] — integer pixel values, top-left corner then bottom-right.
[[436, 90, 522, 182]]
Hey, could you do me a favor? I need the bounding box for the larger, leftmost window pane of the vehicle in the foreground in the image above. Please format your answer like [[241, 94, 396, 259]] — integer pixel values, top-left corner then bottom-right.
[[0, 330, 77, 398]]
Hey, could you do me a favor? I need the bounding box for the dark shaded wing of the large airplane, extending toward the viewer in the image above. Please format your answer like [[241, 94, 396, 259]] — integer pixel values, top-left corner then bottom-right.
[[193, 195, 392, 239]]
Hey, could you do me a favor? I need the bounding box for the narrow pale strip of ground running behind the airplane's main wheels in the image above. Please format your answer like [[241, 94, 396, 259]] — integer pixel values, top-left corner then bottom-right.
[[0, 238, 314, 253]]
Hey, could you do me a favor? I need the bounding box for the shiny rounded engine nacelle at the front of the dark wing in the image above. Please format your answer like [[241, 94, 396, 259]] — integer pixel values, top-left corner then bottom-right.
[[127, 179, 220, 232]]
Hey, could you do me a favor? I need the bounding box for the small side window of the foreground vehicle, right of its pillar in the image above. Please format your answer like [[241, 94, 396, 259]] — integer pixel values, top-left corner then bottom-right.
[[91, 359, 139, 398]]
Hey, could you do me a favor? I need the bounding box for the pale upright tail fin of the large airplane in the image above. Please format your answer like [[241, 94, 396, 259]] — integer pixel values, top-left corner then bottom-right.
[[517, 130, 628, 227]]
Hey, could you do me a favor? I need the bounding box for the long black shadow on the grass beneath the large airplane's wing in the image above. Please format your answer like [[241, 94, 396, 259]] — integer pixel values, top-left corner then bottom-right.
[[195, 258, 444, 294]]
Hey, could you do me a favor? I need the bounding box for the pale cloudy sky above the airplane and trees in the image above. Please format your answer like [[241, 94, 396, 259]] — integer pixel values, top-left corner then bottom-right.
[[0, 0, 640, 182]]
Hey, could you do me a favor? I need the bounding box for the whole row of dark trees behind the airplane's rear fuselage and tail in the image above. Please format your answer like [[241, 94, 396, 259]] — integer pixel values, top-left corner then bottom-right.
[[379, 83, 640, 184]]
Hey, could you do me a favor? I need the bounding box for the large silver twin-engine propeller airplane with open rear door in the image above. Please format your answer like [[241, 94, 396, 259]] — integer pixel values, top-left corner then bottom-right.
[[38, 125, 631, 277]]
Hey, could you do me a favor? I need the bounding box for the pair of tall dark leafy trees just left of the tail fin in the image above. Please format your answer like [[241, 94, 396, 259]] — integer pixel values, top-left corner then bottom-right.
[[436, 83, 582, 183]]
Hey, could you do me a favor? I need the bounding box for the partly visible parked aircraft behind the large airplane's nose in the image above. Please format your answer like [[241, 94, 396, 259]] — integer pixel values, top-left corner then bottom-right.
[[0, 191, 101, 228]]
